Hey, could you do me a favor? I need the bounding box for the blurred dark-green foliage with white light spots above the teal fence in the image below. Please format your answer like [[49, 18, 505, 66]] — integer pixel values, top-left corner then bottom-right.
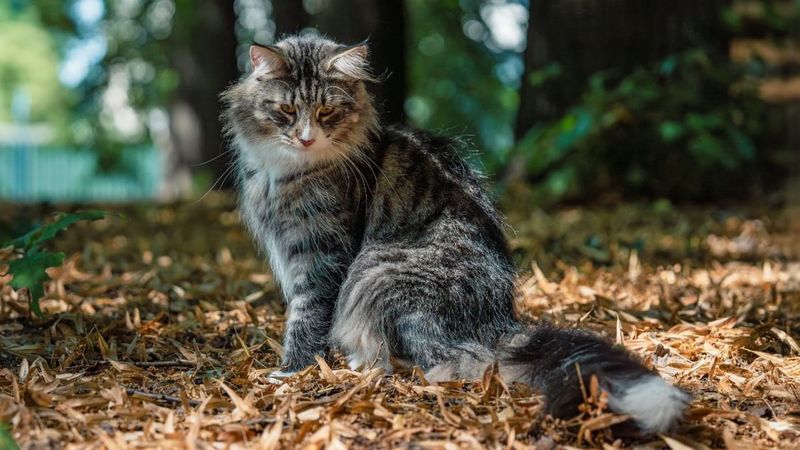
[[31, 0, 181, 171]]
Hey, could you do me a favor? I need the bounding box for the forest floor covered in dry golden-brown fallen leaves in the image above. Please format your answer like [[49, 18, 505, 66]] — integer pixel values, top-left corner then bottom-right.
[[0, 195, 800, 449]]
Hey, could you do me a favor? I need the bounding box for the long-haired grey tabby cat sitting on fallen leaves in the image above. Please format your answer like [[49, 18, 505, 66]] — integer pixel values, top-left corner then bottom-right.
[[222, 36, 689, 431]]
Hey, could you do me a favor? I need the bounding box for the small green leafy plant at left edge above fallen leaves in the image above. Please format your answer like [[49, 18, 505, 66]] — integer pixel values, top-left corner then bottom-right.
[[3, 211, 108, 317]]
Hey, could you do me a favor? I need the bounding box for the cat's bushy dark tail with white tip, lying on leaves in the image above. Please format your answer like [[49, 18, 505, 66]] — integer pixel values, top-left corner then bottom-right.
[[497, 324, 690, 432]]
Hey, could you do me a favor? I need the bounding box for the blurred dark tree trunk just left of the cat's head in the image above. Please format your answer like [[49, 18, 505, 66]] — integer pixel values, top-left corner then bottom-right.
[[164, 0, 239, 198]]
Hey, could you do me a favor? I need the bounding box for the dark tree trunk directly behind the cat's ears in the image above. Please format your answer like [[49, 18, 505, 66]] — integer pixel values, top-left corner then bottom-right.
[[311, 0, 406, 123]]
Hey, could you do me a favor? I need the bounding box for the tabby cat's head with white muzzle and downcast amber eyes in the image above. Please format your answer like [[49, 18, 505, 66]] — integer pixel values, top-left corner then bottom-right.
[[222, 35, 377, 176]]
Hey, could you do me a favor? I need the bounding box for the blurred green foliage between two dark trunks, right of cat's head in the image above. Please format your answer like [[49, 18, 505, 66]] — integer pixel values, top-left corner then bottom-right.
[[406, 0, 521, 173]]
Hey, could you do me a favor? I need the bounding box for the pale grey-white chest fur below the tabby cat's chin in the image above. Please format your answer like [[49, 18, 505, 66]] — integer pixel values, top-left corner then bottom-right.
[[240, 167, 352, 299]]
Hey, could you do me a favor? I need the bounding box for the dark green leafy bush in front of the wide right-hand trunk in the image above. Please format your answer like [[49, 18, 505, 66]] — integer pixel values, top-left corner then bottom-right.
[[515, 0, 800, 203]]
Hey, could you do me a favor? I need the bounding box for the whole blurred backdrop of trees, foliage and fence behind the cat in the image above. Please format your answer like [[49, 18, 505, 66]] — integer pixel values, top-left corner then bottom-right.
[[0, 0, 800, 206]]
